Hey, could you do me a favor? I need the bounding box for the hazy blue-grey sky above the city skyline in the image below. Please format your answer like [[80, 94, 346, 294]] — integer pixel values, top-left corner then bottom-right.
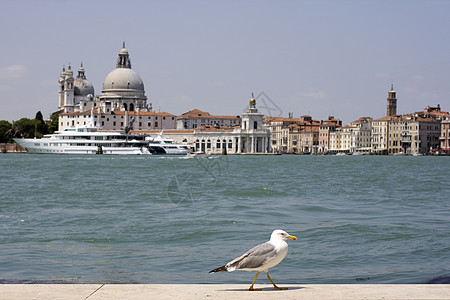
[[0, 0, 450, 124]]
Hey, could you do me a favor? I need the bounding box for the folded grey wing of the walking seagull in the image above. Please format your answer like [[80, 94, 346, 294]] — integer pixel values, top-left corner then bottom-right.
[[227, 242, 277, 269]]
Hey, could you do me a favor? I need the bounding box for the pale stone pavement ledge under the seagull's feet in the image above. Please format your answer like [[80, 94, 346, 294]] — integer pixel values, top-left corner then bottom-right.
[[0, 284, 450, 300]]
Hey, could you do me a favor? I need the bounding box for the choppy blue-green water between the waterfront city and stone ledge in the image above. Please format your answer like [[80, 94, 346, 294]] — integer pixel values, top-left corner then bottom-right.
[[0, 154, 450, 284]]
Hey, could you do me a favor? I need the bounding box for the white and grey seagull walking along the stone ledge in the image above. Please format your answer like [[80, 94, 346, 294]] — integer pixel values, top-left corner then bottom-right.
[[209, 229, 297, 291]]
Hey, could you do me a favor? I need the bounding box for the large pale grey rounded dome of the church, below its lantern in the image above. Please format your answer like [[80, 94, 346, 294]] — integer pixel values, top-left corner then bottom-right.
[[102, 68, 144, 92]]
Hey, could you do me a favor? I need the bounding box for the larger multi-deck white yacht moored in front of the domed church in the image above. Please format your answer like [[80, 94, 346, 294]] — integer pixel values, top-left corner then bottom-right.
[[14, 112, 150, 155]]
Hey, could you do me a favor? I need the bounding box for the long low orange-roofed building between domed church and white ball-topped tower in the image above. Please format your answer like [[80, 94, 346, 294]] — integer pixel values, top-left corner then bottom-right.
[[177, 109, 241, 130]]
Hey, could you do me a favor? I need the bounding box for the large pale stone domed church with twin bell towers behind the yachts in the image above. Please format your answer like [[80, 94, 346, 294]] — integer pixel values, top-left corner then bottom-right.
[[58, 42, 176, 130]]
